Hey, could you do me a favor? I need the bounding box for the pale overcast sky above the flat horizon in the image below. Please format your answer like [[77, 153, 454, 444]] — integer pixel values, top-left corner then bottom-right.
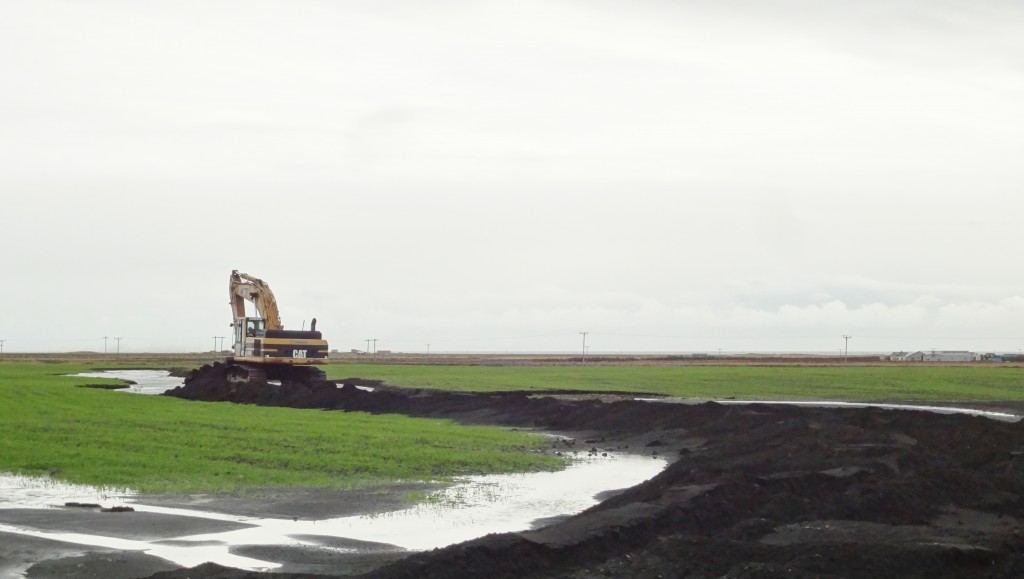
[[0, 0, 1024, 351]]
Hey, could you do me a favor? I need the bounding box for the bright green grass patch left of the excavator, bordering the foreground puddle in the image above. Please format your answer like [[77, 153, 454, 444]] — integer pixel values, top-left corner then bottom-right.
[[0, 363, 561, 492]]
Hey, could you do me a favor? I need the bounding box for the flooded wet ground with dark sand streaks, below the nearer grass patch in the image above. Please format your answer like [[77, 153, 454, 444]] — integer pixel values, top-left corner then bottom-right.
[[0, 454, 666, 571]]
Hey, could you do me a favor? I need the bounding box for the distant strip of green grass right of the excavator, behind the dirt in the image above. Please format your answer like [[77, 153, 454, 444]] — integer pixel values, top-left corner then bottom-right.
[[327, 364, 1024, 401]]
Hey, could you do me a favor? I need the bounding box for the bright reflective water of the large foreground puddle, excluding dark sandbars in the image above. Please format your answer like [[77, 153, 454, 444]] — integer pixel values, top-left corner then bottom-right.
[[0, 453, 667, 571]]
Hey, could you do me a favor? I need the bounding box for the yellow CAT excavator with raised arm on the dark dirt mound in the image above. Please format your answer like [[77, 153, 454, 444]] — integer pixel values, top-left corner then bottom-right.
[[227, 270, 329, 382]]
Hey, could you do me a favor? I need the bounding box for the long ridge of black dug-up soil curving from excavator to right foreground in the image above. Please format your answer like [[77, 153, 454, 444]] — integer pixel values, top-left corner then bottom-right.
[[162, 370, 1024, 579]]
